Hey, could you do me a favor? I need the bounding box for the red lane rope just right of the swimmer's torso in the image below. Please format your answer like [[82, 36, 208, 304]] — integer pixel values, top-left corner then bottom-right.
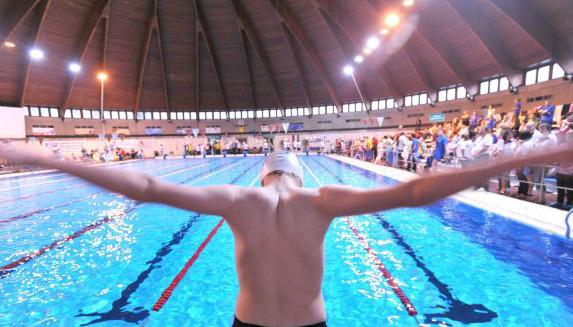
[[300, 160, 418, 317]]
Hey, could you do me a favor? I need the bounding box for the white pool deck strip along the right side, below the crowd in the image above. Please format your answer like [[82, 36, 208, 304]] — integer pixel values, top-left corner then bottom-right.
[[328, 155, 567, 237]]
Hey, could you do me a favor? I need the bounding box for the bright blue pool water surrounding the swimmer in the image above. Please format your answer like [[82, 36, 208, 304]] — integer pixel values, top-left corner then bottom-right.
[[0, 156, 573, 326]]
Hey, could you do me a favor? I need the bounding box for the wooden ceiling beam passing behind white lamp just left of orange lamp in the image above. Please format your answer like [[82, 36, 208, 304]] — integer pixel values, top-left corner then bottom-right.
[[58, 0, 109, 120]]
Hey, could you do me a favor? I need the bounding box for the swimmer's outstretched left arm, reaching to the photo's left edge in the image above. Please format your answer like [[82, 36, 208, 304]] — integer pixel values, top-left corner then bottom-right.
[[0, 145, 239, 216]]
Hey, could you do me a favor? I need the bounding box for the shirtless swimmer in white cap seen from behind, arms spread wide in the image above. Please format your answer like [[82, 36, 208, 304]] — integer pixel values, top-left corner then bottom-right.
[[0, 145, 573, 326]]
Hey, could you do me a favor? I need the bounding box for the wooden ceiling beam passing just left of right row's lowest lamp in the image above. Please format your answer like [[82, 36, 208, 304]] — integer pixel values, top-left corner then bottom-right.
[[269, 0, 342, 113]]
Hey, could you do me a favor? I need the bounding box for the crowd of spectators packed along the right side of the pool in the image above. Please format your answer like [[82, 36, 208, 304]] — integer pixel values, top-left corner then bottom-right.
[[333, 99, 573, 209]]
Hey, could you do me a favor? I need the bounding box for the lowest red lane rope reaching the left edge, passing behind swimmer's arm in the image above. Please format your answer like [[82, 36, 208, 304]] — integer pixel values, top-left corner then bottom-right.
[[0, 161, 245, 278]]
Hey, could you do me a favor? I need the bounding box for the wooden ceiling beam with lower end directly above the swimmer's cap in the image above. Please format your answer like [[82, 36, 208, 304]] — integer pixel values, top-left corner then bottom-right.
[[229, 0, 285, 117]]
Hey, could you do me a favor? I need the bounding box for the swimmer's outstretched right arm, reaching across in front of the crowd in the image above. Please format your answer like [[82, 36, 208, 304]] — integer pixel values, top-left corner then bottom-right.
[[318, 147, 573, 218]]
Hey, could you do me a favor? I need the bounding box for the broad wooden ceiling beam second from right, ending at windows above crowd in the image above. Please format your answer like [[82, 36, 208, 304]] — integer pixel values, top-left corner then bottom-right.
[[443, 0, 523, 86]]
